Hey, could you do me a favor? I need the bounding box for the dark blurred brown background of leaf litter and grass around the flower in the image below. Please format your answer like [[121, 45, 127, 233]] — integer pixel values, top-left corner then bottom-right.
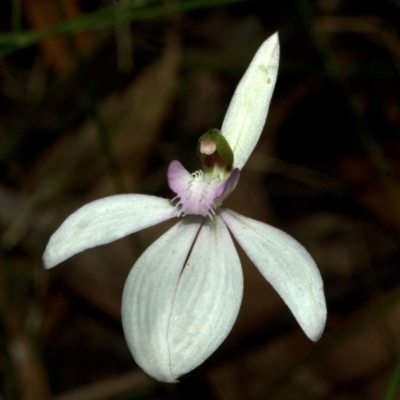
[[0, 0, 400, 400]]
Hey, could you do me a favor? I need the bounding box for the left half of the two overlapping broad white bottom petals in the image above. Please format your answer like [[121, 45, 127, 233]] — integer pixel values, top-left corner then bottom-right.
[[122, 216, 204, 382]]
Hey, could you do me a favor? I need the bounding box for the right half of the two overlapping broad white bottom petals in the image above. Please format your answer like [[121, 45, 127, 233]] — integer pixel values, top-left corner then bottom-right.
[[168, 215, 243, 378]]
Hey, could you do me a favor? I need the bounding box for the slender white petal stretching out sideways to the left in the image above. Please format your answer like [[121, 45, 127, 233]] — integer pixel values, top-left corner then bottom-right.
[[43, 194, 176, 268]]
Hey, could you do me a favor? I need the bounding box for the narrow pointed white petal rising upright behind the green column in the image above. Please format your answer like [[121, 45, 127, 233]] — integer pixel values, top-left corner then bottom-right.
[[221, 33, 279, 169]]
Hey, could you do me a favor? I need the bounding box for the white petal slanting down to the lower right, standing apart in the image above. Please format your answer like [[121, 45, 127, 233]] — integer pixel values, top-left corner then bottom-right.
[[221, 210, 326, 341]]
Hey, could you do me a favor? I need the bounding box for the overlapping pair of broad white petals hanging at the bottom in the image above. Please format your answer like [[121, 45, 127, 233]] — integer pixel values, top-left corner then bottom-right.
[[122, 216, 243, 382]]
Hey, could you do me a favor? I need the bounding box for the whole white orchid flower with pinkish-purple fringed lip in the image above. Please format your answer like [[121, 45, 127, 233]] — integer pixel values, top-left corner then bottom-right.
[[43, 33, 326, 382]]
